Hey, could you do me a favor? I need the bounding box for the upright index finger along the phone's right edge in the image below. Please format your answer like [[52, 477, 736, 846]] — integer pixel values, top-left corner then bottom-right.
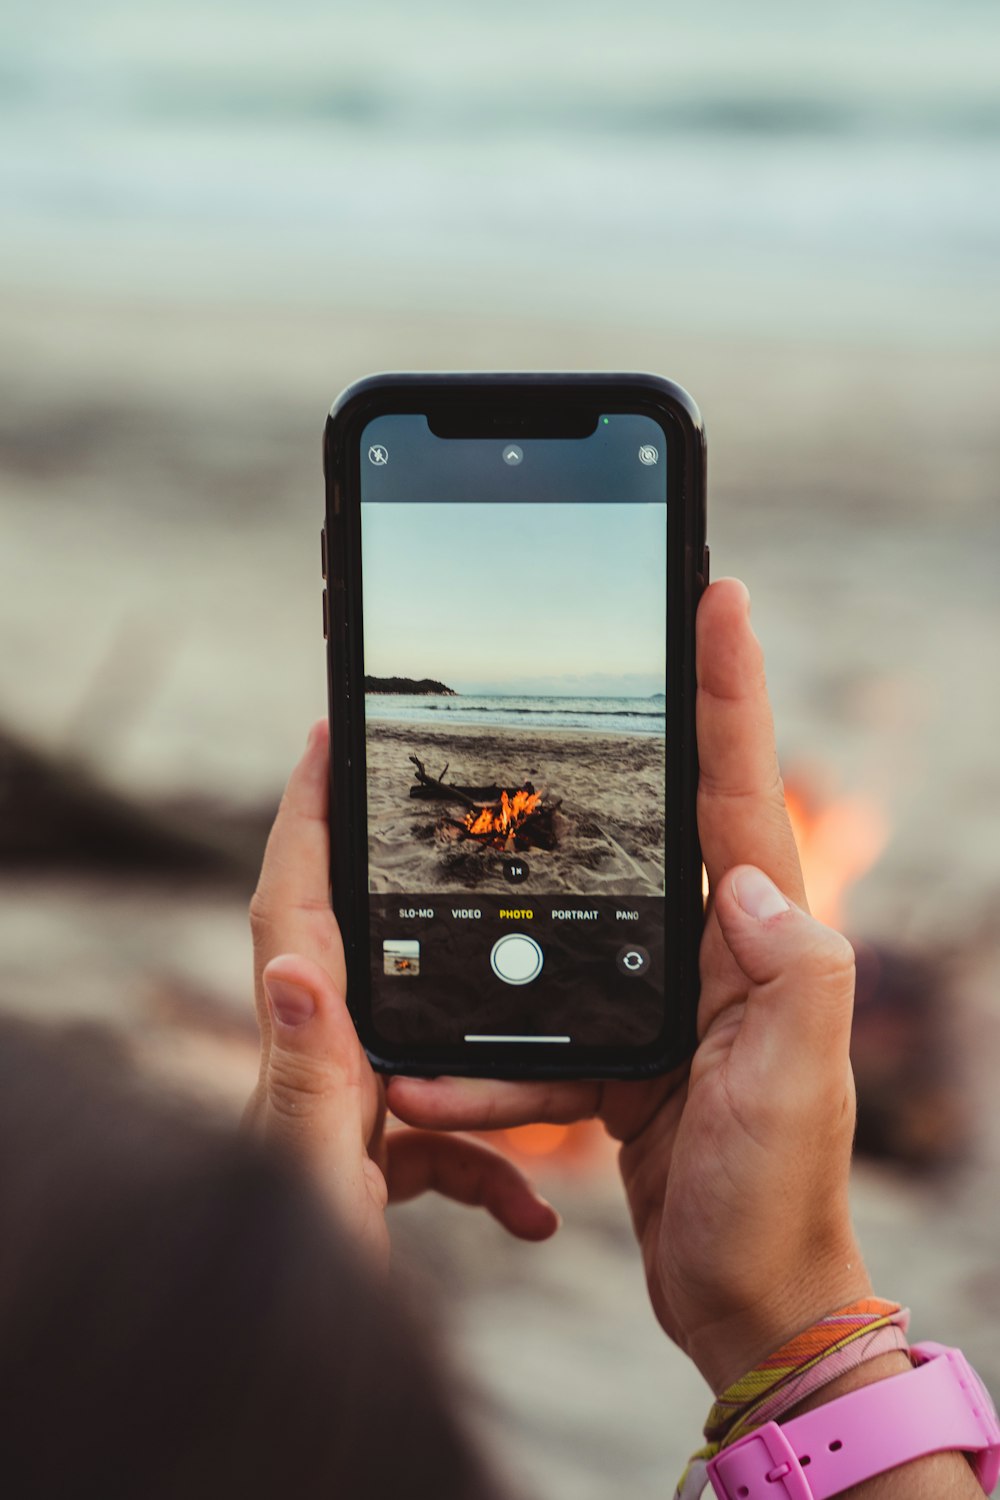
[[697, 578, 805, 906]]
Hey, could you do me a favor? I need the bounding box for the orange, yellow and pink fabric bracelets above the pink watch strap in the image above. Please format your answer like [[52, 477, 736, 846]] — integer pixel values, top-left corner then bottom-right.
[[675, 1298, 910, 1500]]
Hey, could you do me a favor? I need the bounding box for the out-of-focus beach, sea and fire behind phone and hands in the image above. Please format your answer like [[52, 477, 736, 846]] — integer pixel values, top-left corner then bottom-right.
[[0, 0, 1000, 1500]]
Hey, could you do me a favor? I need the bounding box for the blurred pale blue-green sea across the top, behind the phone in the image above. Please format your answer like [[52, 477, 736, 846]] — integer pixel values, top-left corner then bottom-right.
[[0, 0, 1000, 341]]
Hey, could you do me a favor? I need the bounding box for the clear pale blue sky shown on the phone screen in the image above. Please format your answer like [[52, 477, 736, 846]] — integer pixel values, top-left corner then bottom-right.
[[361, 504, 666, 696]]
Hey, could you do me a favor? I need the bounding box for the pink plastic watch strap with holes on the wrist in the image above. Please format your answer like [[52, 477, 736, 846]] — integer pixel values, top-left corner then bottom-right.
[[708, 1344, 1000, 1500]]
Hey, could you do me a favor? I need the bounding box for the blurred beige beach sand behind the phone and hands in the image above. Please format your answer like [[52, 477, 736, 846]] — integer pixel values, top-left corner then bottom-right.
[[0, 283, 1000, 1500]]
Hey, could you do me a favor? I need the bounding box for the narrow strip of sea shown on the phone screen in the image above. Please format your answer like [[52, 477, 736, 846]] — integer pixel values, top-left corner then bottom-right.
[[364, 693, 666, 735]]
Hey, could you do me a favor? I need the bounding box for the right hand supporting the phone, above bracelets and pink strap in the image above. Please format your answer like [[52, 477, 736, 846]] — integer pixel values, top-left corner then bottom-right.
[[387, 579, 871, 1391]]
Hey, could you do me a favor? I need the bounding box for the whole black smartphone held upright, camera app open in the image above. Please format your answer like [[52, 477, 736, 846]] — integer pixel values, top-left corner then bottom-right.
[[322, 374, 708, 1079]]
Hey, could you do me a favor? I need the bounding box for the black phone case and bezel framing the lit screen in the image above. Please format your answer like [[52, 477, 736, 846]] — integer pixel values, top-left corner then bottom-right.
[[322, 374, 708, 1079]]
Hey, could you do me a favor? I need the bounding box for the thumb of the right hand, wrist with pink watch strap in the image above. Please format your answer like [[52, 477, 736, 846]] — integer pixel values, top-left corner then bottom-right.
[[715, 864, 855, 1073]]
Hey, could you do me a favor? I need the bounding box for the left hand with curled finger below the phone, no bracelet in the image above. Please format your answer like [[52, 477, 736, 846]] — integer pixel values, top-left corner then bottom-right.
[[244, 723, 559, 1262]]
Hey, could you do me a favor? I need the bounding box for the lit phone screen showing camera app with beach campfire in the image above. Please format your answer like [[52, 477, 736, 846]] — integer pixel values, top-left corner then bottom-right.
[[358, 413, 669, 1052]]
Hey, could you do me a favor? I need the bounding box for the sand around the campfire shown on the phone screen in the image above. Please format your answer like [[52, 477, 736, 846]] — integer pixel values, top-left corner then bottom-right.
[[367, 720, 664, 897]]
